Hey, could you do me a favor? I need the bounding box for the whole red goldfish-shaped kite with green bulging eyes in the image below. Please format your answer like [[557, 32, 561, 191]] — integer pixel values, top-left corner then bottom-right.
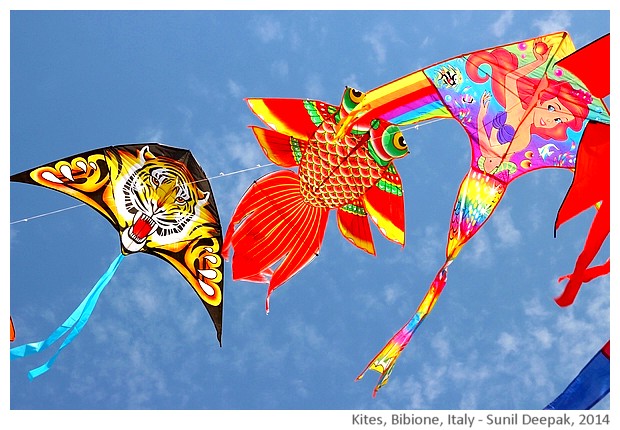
[[222, 87, 409, 312]]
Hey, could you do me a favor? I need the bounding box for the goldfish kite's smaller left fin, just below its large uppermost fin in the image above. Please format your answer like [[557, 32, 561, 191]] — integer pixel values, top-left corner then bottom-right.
[[251, 126, 308, 167]]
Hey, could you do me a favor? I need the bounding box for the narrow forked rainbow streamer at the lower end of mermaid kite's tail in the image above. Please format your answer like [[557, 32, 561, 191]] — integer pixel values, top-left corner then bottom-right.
[[356, 260, 451, 397]]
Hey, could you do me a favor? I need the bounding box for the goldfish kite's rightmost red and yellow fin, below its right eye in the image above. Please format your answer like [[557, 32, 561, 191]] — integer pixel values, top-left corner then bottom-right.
[[364, 164, 405, 246]]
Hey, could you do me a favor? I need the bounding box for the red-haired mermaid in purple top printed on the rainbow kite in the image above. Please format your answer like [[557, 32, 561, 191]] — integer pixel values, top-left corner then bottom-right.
[[465, 40, 592, 174]]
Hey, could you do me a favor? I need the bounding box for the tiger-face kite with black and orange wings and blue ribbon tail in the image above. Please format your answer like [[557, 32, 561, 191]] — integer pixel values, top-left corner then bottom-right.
[[11, 143, 224, 380]]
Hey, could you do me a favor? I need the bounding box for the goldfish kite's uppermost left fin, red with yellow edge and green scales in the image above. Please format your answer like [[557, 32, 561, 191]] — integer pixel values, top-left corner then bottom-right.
[[246, 98, 338, 140]]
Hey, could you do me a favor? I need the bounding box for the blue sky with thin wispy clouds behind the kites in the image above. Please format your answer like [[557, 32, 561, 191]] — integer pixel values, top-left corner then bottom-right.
[[3, 5, 610, 418]]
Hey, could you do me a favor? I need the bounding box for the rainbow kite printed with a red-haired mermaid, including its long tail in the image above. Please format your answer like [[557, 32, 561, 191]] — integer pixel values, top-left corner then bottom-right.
[[352, 32, 609, 397]]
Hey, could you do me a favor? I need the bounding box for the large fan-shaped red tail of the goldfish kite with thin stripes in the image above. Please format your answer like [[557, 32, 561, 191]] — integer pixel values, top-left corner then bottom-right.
[[222, 170, 329, 310]]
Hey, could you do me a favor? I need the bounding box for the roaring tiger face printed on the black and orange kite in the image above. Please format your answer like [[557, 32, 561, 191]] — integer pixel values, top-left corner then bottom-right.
[[115, 147, 209, 253]]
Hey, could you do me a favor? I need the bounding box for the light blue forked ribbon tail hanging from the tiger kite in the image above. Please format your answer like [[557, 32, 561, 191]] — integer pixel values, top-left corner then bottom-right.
[[11, 254, 125, 381]]
